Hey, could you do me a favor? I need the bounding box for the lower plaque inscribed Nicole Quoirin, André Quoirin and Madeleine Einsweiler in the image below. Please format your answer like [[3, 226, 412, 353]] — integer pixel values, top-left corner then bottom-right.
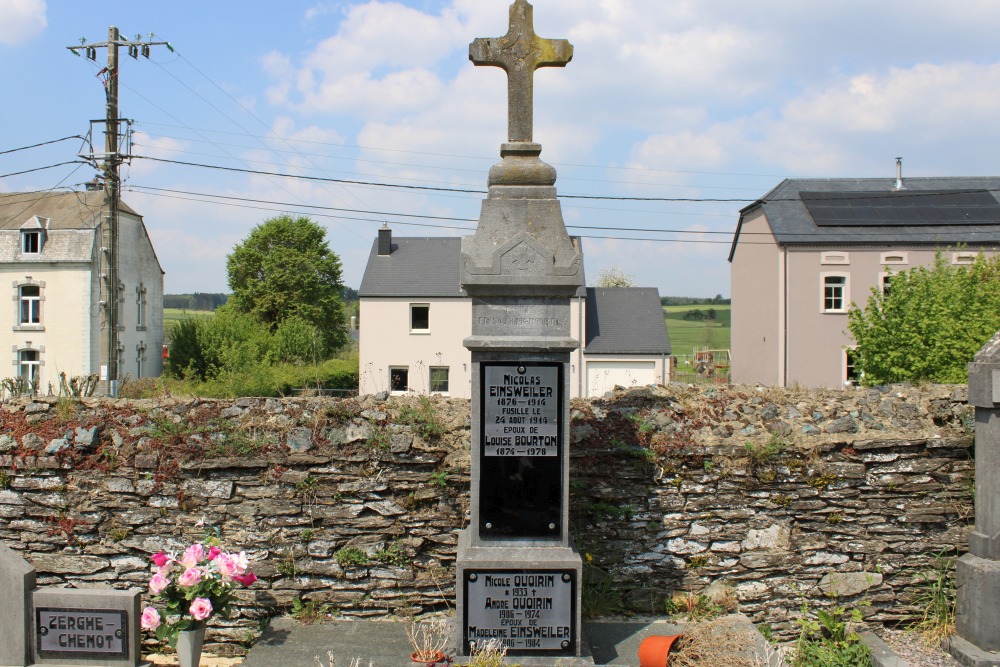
[[462, 570, 577, 655]]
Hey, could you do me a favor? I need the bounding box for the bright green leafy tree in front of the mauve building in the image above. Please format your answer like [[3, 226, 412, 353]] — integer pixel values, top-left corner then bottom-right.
[[848, 252, 1000, 385]]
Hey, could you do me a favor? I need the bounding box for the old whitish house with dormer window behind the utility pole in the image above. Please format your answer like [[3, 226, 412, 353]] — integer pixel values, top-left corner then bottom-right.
[[0, 192, 163, 393]]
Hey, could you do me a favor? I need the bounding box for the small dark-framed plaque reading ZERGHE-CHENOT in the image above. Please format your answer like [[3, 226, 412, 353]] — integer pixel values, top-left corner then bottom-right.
[[35, 607, 128, 659]]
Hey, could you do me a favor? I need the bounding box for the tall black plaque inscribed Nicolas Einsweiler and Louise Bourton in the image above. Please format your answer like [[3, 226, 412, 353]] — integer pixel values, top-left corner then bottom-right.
[[479, 362, 566, 538]]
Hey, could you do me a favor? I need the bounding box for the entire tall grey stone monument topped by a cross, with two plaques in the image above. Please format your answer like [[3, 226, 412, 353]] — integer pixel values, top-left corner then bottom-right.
[[456, 0, 583, 656]]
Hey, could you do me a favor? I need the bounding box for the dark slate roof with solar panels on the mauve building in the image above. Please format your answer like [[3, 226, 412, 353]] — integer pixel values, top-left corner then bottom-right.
[[729, 176, 1000, 262]]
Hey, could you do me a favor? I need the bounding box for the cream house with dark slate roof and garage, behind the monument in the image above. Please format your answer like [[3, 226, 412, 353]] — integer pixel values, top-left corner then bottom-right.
[[358, 227, 670, 398]]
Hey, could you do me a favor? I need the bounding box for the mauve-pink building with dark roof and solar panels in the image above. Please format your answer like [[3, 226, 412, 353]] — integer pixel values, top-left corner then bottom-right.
[[729, 177, 1000, 387]]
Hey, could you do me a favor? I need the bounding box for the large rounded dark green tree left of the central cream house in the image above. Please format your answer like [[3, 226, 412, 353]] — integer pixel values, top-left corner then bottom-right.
[[226, 215, 347, 358]]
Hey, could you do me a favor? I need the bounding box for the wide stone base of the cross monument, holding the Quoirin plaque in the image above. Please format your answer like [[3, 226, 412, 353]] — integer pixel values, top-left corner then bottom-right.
[[455, 529, 583, 663]]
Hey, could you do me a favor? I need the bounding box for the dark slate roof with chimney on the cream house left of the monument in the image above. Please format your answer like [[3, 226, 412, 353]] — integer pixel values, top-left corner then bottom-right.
[[358, 237, 466, 297]]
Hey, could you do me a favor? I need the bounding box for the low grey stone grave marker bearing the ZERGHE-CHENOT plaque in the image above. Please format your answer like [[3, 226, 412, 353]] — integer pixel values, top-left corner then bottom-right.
[[0, 544, 141, 667]]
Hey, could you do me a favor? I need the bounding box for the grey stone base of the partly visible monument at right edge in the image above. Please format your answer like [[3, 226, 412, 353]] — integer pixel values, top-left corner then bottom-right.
[[950, 553, 1000, 667]]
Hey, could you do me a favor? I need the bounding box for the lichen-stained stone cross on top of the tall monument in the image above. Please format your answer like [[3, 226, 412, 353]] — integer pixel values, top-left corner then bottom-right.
[[469, 0, 573, 142]]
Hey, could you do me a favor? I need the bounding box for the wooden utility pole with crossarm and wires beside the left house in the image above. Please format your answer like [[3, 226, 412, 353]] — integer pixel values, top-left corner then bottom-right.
[[66, 26, 174, 396]]
